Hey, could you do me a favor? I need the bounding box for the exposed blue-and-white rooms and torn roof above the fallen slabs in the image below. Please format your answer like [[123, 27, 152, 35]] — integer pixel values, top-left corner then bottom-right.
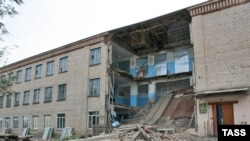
[[106, 10, 193, 121]]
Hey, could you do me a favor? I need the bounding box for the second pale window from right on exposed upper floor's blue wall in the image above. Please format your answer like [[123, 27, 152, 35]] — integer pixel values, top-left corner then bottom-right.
[[154, 53, 167, 76]]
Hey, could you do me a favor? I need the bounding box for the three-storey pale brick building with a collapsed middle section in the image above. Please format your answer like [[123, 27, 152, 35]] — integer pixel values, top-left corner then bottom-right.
[[0, 0, 249, 139]]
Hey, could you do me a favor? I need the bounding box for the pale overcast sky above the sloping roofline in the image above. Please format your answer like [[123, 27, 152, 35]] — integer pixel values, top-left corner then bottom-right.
[[0, 0, 207, 64]]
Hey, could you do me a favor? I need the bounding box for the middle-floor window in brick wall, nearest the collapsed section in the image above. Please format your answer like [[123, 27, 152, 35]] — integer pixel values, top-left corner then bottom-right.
[[89, 78, 100, 96]]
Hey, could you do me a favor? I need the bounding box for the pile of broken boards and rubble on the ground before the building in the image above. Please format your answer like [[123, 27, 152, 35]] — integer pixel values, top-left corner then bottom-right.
[[78, 125, 217, 141]]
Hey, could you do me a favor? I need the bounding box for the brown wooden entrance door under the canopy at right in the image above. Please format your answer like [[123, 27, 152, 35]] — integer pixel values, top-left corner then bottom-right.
[[212, 103, 234, 136]]
